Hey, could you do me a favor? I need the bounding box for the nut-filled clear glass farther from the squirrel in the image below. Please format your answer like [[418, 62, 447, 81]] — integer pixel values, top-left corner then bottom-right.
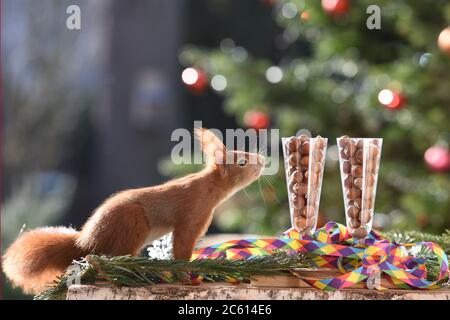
[[337, 136, 383, 241]]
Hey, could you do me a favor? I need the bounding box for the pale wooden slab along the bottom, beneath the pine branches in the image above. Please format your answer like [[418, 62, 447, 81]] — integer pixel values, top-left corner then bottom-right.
[[67, 283, 450, 300]]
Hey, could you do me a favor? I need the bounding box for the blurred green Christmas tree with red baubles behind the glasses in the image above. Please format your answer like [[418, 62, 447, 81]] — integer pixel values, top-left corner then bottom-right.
[[176, 0, 450, 233]]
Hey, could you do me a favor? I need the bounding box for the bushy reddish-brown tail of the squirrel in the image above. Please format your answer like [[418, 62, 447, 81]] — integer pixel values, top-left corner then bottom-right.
[[2, 227, 82, 293]]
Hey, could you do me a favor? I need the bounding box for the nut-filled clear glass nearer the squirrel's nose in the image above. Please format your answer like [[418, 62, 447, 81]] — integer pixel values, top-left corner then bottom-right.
[[282, 135, 328, 234]]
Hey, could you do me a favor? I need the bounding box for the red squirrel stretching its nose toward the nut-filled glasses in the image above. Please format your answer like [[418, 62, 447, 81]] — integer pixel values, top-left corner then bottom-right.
[[2, 128, 265, 293]]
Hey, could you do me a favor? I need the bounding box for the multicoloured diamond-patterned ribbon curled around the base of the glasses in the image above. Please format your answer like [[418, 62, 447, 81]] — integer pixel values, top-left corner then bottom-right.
[[191, 222, 449, 290]]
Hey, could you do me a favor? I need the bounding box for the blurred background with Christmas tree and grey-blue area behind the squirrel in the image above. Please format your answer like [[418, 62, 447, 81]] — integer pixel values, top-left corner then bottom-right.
[[2, 0, 450, 298]]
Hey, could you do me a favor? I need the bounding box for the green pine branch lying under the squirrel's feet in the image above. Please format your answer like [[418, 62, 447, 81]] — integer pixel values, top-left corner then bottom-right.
[[35, 252, 313, 300]]
